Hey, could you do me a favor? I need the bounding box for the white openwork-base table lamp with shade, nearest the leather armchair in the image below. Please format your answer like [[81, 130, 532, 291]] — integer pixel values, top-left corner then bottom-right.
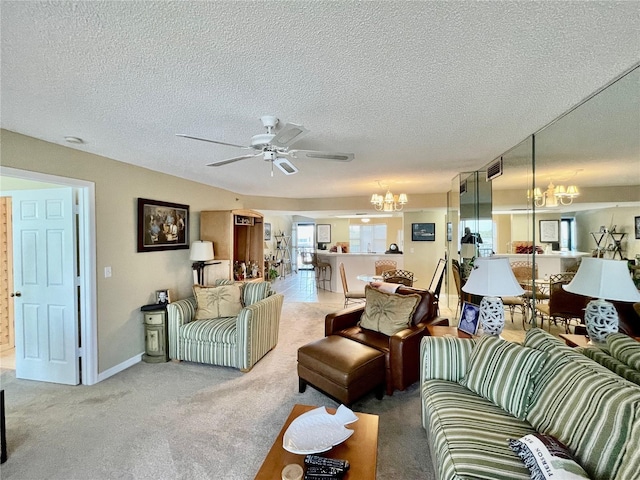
[[462, 257, 524, 335]]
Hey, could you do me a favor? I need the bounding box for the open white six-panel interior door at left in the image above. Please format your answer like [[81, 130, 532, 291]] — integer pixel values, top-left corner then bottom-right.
[[12, 188, 80, 385]]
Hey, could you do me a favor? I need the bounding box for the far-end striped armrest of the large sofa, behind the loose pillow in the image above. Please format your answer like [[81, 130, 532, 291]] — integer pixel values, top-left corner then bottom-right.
[[420, 335, 475, 383]]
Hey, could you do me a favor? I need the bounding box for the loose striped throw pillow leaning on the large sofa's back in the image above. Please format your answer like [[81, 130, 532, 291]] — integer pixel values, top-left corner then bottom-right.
[[460, 335, 548, 420]]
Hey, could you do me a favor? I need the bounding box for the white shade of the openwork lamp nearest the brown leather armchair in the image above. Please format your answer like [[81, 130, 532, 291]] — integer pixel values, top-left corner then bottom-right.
[[462, 257, 524, 297]]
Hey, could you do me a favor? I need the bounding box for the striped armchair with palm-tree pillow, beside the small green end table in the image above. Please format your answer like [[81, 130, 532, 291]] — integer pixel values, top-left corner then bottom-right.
[[167, 282, 284, 372]]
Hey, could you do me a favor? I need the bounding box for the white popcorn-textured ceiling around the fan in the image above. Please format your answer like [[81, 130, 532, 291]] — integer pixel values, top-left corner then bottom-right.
[[1, 0, 640, 198]]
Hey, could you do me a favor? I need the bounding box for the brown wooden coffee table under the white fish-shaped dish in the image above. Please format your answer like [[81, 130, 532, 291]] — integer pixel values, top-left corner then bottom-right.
[[256, 404, 378, 480]]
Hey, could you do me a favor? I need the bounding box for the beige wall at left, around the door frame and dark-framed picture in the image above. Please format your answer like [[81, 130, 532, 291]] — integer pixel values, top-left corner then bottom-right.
[[0, 130, 244, 373]]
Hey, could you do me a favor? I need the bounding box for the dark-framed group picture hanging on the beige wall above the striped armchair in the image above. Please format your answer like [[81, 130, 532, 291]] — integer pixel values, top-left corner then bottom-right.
[[138, 198, 189, 252]]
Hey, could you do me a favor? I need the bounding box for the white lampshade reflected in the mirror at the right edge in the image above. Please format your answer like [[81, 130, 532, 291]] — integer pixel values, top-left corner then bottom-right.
[[563, 257, 640, 302]]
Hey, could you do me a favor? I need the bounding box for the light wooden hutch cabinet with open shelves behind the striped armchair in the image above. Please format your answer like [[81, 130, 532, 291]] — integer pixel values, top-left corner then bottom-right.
[[200, 210, 264, 278]]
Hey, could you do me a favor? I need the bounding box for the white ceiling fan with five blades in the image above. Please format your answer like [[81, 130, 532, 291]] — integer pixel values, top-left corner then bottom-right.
[[176, 115, 354, 177]]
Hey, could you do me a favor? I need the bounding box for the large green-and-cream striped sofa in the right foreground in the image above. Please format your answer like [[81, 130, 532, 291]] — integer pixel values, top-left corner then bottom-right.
[[420, 329, 640, 480]]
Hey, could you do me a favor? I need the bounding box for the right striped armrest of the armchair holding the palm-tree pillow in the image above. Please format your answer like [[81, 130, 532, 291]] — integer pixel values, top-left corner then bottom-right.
[[236, 293, 284, 371]]
